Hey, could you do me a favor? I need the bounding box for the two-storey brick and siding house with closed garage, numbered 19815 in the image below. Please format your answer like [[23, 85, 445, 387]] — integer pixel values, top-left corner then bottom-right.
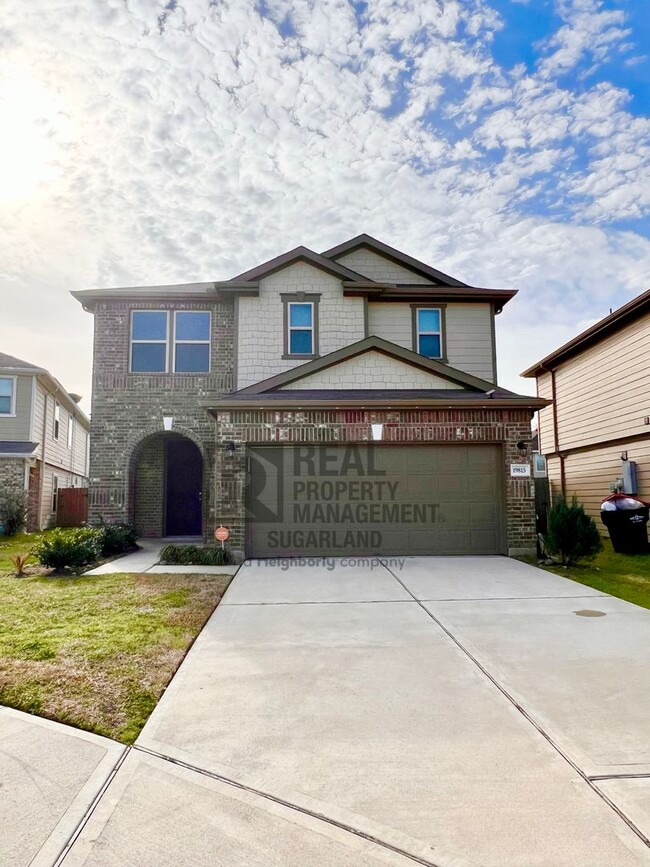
[[73, 235, 545, 556]]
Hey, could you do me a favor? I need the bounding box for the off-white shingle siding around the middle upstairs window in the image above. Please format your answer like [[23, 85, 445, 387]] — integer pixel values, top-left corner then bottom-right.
[[237, 262, 365, 388]]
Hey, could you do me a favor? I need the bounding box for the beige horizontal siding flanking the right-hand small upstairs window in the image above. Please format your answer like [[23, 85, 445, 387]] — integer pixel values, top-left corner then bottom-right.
[[368, 302, 494, 382]]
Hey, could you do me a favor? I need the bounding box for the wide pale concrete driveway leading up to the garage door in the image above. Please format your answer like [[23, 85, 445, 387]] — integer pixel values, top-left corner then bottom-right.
[[3, 557, 650, 867]]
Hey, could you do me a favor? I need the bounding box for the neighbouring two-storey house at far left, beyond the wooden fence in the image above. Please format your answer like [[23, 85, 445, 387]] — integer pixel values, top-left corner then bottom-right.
[[0, 352, 90, 531]]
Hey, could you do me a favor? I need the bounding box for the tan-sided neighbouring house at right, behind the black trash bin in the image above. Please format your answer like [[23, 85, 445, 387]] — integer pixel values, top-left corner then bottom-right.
[[522, 292, 650, 532]]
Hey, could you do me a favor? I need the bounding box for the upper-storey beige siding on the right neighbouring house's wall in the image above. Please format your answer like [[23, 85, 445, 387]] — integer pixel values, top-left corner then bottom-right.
[[555, 314, 650, 450]]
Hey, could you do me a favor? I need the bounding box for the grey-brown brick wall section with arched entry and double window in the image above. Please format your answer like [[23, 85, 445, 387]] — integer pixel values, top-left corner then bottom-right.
[[89, 295, 234, 535]]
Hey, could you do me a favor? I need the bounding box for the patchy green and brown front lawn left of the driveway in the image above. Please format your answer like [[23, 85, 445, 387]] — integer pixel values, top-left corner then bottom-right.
[[0, 534, 230, 744]]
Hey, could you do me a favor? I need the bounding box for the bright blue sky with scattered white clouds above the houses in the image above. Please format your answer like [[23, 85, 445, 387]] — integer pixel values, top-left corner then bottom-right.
[[0, 0, 650, 412]]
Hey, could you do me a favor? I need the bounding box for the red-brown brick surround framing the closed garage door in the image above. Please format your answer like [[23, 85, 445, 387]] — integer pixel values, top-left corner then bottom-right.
[[214, 409, 536, 555]]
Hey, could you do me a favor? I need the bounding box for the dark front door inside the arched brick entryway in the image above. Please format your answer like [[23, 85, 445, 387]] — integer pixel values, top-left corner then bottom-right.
[[165, 439, 203, 536]]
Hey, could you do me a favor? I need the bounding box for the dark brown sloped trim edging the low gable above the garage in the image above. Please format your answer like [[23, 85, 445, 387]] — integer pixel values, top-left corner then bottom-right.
[[238, 335, 502, 394]]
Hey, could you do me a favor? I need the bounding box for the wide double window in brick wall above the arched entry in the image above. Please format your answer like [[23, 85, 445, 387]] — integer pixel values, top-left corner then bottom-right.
[[130, 310, 211, 373]]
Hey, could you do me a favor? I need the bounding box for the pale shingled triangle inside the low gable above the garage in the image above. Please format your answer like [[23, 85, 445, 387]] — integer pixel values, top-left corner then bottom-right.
[[283, 352, 462, 391]]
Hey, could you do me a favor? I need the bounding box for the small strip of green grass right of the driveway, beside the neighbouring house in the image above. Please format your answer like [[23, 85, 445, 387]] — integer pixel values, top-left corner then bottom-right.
[[528, 539, 650, 608]]
